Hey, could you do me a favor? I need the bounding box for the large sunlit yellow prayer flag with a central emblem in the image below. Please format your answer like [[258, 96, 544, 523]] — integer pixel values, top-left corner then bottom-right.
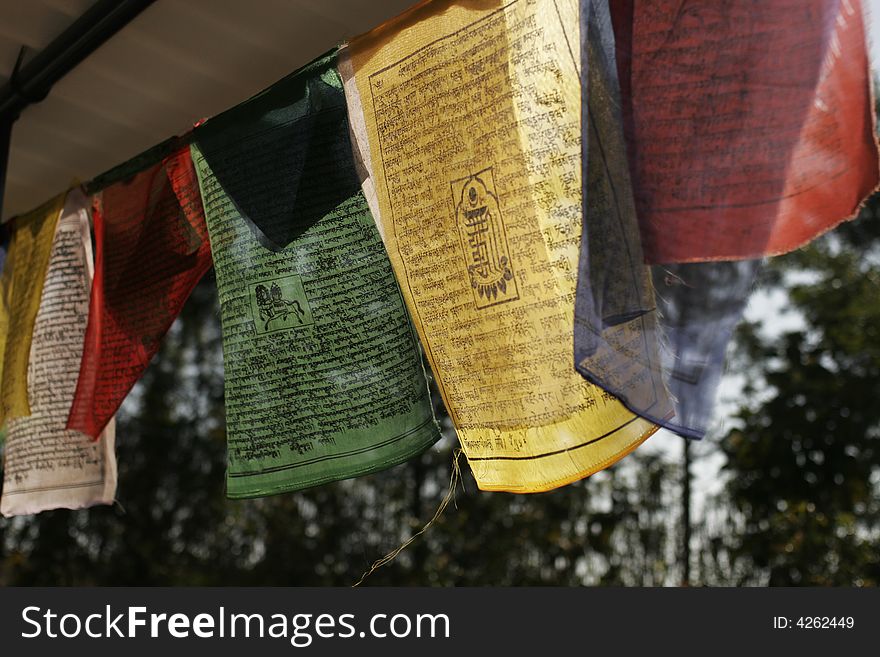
[[340, 0, 656, 493]]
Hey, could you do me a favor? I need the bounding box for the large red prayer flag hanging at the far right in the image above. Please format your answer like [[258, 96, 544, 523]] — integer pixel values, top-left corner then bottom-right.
[[611, 0, 878, 263]]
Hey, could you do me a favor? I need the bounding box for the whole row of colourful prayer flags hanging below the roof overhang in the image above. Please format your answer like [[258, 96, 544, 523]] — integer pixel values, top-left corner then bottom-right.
[[0, 0, 878, 515]]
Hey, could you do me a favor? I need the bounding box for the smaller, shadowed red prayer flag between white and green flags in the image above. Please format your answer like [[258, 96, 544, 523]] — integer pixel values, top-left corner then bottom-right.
[[67, 148, 211, 438]]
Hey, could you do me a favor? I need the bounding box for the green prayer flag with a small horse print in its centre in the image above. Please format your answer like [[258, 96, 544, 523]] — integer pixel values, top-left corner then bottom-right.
[[192, 52, 440, 498]]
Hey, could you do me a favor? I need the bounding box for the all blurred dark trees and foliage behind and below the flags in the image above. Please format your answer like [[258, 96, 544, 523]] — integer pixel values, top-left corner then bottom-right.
[[0, 199, 880, 586]]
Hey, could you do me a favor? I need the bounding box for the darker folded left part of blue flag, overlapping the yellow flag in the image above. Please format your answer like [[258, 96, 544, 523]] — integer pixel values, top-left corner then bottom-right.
[[574, 0, 672, 430]]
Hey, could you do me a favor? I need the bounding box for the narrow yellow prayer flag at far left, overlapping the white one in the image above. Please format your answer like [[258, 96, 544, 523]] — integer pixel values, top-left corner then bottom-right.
[[0, 193, 67, 426]]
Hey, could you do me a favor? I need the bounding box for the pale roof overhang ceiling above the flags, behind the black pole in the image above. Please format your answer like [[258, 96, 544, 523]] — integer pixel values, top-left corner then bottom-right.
[[0, 0, 414, 219]]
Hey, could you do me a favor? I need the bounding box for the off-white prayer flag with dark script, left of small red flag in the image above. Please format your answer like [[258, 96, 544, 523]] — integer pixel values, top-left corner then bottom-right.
[[0, 190, 116, 516]]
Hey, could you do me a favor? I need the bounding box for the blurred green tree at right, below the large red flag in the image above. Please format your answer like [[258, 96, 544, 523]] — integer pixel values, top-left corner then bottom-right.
[[706, 196, 880, 586]]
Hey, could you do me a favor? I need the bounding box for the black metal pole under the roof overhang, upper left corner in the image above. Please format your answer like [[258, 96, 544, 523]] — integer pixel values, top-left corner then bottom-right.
[[0, 0, 155, 220]]
